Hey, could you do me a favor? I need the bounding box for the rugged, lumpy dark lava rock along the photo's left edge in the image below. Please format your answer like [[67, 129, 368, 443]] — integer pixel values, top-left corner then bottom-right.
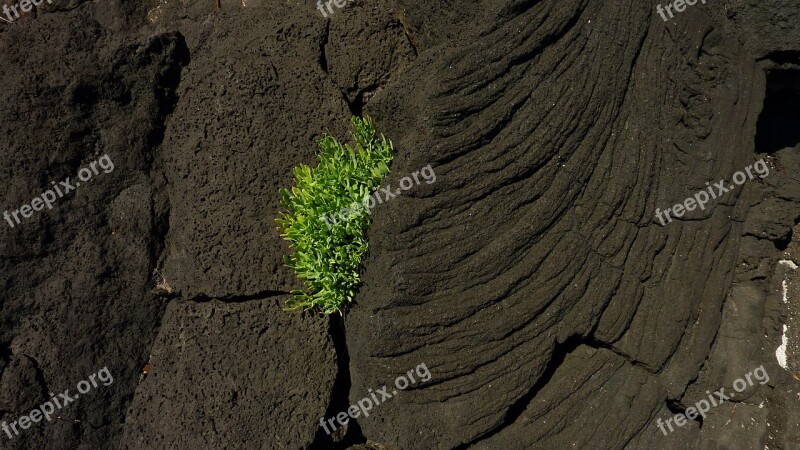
[[0, 3, 186, 448]]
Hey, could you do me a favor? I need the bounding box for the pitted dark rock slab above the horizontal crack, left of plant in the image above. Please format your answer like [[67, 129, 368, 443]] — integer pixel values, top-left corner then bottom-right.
[[160, 4, 347, 298]]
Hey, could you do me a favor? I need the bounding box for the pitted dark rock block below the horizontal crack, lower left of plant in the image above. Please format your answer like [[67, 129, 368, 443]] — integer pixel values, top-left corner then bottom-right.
[[121, 297, 336, 448]]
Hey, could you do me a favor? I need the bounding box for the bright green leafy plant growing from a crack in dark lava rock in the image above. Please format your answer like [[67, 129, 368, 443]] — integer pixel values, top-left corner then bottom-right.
[[276, 117, 394, 314]]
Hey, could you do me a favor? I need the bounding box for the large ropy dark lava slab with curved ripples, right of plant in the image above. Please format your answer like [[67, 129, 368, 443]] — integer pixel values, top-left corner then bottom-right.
[[348, 1, 800, 448]]
